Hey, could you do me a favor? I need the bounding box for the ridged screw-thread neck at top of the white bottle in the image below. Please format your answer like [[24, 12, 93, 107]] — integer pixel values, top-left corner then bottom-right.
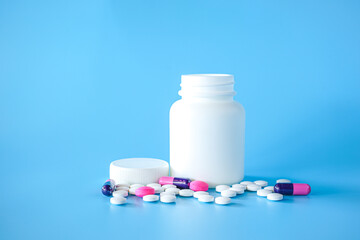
[[179, 74, 236, 101]]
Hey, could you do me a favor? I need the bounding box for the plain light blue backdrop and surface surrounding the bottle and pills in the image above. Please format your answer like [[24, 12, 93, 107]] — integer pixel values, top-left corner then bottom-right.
[[0, 0, 360, 239]]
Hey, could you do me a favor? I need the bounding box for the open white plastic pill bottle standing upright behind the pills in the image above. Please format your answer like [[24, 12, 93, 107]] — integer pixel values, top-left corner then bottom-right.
[[170, 74, 245, 188]]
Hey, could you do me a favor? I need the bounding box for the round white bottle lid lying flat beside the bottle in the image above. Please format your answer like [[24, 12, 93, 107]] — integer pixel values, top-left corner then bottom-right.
[[110, 158, 169, 185]]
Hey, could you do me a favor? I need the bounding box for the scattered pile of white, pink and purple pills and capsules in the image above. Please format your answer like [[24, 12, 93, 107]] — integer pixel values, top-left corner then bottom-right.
[[101, 176, 311, 205]]
